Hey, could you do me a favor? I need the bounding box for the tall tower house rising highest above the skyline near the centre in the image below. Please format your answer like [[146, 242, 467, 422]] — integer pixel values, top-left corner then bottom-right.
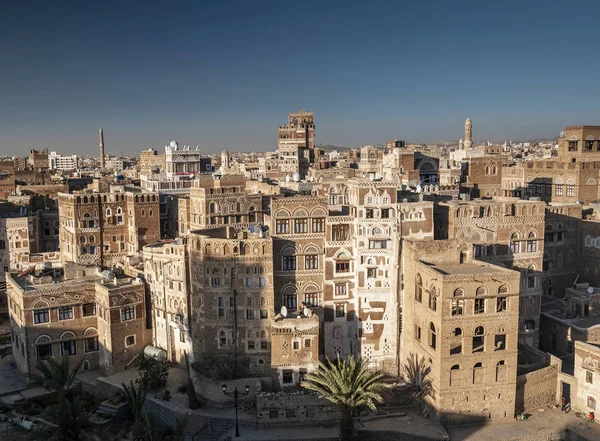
[[277, 110, 315, 179]]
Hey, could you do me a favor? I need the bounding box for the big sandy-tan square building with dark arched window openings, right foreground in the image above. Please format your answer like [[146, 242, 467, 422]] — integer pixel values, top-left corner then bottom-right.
[[402, 240, 520, 422]]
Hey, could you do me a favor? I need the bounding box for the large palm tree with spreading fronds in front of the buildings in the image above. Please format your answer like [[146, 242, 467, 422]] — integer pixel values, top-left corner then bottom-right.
[[301, 355, 390, 441]]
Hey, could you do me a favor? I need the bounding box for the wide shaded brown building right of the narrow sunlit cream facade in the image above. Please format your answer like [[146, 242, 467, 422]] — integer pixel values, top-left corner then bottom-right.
[[188, 226, 275, 375]]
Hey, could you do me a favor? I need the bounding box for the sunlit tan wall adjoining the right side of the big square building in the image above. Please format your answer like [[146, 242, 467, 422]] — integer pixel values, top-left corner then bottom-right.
[[515, 357, 560, 414]]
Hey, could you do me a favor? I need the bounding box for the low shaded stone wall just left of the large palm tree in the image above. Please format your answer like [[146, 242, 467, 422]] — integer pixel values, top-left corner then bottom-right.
[[256, 391, 340, 427]]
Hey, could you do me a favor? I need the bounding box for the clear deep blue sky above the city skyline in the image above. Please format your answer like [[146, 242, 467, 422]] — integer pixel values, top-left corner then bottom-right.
[[0, 0, 600, 155]]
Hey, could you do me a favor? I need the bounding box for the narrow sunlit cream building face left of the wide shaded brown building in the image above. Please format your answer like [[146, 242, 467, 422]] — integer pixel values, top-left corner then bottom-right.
[[142, 239, 194, 363]]
